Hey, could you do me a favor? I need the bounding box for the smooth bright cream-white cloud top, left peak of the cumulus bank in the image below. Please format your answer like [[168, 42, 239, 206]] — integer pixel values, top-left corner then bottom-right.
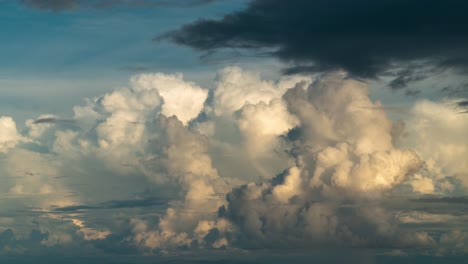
[[131, 73, 208, 125]]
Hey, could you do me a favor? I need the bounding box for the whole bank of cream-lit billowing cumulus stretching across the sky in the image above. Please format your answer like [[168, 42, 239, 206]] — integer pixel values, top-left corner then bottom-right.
[[0, 67, 466, 255]]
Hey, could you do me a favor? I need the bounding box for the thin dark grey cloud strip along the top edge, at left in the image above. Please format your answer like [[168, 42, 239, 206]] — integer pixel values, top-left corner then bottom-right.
[[18, 0, 216, 11]]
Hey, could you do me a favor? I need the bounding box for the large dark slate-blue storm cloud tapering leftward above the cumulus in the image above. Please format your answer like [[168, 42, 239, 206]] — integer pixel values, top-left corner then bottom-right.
[[164, 0, 468, 78]]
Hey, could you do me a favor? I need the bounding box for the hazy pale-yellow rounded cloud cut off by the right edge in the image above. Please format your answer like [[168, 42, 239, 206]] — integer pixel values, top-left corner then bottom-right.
[[404, 101, 468, 187]]
